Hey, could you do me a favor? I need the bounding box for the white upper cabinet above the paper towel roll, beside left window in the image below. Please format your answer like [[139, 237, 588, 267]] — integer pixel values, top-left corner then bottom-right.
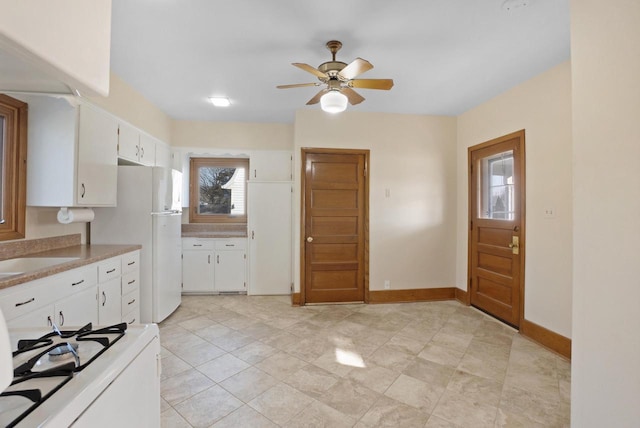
[[16, 95, 118, 207]]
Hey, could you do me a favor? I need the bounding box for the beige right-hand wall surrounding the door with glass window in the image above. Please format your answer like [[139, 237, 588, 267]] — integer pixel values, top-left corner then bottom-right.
[[456, 62, 572, 337]]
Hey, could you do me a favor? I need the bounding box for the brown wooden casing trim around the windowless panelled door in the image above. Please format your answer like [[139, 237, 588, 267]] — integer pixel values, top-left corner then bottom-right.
[[299, 147, 371, 305]]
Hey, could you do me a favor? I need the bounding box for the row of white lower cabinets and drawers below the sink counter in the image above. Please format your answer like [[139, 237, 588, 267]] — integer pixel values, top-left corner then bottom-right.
[[0, 251, 140, 328]]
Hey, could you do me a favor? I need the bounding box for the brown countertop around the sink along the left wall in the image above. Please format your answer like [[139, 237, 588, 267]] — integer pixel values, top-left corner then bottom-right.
[[0, 245, 142, 290]]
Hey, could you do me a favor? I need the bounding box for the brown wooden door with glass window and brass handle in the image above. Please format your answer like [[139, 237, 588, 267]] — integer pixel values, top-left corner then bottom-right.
[[469, 130, 525, 327]]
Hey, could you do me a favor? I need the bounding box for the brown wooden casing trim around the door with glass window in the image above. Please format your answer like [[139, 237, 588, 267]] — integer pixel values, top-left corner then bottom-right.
[[464, 129, 527, 328]]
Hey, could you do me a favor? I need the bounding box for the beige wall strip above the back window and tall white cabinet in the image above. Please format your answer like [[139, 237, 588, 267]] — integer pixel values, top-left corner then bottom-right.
[[171, 120, 293, 150]]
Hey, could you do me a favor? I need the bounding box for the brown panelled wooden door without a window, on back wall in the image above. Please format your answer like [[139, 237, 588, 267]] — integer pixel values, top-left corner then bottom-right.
[[301, 149, 369, 303]]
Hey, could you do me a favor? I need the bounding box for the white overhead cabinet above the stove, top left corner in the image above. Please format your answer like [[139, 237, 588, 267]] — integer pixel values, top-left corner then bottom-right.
[[0, 0, 111, 96]]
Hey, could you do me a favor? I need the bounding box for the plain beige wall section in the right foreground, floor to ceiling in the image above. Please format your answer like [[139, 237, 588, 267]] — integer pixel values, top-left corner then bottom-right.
[[571, 0, 640, 428]]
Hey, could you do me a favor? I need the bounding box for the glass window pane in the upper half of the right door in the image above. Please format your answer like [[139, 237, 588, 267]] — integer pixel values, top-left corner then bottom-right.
[[478, 150, 515, 220]]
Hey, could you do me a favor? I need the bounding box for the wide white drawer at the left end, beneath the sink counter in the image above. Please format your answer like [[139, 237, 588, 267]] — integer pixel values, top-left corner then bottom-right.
[[0, 275, 62, 321]]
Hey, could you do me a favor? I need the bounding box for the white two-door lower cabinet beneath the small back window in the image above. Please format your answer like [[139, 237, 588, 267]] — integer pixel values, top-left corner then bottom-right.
[[182, 238, 247, 294]]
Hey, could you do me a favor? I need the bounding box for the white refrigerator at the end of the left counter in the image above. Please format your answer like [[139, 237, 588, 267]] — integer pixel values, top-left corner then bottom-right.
[[90, 165, 182, 323]]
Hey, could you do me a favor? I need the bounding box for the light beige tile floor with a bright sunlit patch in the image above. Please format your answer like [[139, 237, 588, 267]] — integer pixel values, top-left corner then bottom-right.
[[160, 296, 571, 428]]
